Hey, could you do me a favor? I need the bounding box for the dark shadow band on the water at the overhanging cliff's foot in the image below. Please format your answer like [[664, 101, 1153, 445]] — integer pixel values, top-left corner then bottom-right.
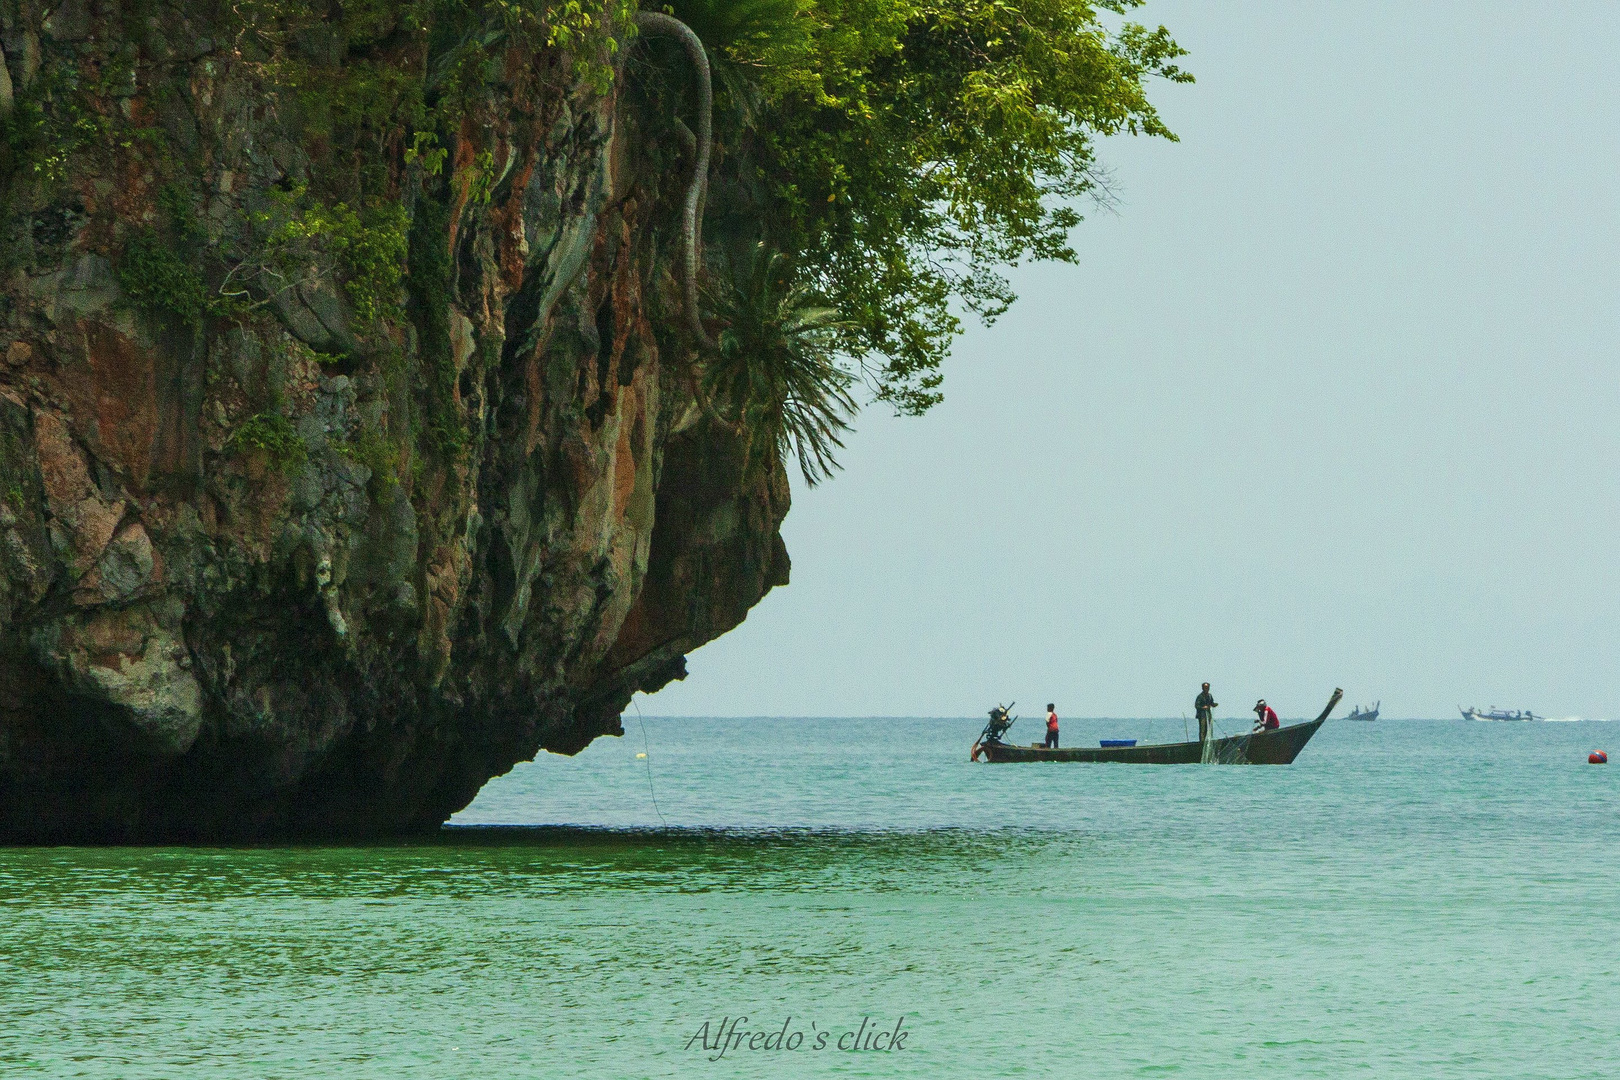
[[0, 826, 1087, 910]]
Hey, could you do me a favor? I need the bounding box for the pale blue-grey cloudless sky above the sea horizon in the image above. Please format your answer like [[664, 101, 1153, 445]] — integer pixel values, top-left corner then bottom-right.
[[638, 0, 1620, 717]]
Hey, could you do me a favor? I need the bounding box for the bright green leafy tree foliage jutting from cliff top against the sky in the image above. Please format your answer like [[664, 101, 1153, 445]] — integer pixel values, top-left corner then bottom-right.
[[671, 0, 1191, 413]]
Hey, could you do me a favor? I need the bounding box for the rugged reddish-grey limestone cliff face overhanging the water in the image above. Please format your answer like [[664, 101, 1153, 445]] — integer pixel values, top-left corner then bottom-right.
[[0, 0, 789, 840]]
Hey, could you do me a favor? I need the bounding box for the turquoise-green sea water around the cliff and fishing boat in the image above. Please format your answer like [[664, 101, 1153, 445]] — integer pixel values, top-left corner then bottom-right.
[[0, 714, 1620, 1078]]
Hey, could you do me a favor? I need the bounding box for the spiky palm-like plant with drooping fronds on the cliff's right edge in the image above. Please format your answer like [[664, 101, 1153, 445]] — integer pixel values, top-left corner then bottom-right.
[[700, 241, 857, 487]]
